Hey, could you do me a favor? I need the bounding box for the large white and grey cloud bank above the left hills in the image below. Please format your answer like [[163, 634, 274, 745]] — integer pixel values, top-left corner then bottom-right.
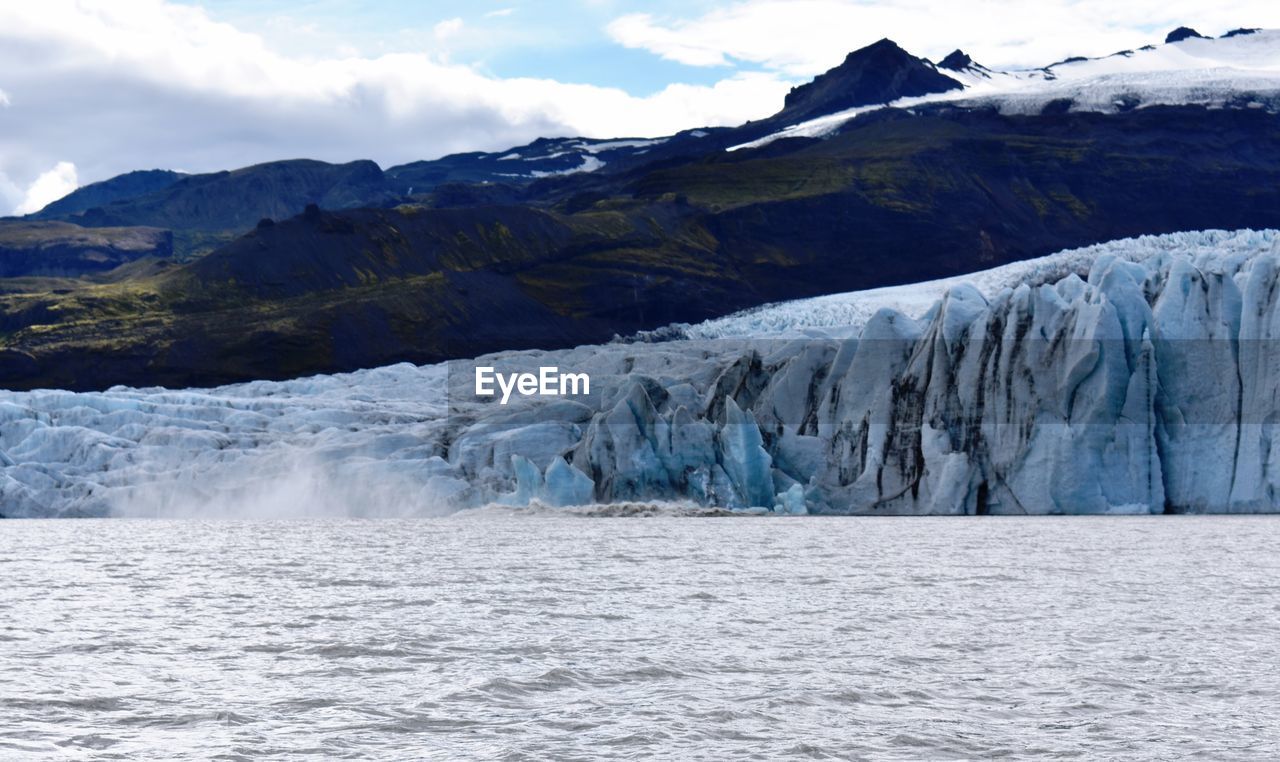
[[0, 0, 792, 207]]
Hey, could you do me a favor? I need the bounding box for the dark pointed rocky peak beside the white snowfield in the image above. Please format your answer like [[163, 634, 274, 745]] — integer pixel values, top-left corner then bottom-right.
[[778, 38, 963, 122]]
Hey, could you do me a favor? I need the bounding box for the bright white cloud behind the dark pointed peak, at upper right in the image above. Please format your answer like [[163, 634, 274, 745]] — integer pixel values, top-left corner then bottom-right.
[[608, 0, 1280, 77]]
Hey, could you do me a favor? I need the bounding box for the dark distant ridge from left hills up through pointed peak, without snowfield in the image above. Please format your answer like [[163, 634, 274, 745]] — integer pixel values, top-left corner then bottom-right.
[[15, 40, 977, 233]]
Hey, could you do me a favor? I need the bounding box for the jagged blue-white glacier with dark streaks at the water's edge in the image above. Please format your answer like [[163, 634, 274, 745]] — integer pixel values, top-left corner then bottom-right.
[[0, 231, 1280, 517]]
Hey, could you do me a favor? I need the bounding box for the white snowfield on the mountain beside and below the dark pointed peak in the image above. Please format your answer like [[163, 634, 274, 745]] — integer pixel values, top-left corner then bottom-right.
[[730, 28, 1280, 150]]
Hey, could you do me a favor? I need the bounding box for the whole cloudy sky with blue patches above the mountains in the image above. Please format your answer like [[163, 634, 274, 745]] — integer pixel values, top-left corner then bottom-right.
[[0, 0, 1280, 214]]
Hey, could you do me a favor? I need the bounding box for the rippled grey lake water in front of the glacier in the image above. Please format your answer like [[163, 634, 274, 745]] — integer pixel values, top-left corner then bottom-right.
[[0, 512, 1280, 759]]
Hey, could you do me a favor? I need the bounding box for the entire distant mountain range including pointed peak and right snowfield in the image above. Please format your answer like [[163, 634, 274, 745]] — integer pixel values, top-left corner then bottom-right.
[[37, 28, 1280, 235]]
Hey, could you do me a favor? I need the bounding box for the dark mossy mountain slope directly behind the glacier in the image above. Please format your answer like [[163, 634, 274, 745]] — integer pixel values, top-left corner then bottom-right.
[[0, 101, 1280, 388]]
